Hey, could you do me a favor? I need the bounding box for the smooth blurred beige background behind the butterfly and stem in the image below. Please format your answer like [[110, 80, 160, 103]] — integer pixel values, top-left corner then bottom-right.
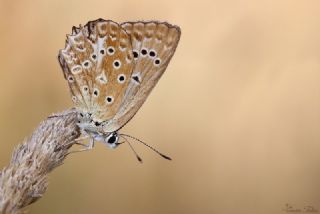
[[0, 0, 320, 214]]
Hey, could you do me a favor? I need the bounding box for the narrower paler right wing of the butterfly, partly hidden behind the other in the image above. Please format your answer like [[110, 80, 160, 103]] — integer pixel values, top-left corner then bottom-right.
[[104, 21, 181, 132]]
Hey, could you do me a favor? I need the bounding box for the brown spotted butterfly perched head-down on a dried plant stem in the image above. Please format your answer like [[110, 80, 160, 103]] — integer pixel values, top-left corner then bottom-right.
[[58, 19, 181, 160]]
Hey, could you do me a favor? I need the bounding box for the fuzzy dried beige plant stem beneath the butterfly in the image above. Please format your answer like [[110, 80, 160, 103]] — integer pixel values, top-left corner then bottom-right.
[[0, 109, 80, 214]]
